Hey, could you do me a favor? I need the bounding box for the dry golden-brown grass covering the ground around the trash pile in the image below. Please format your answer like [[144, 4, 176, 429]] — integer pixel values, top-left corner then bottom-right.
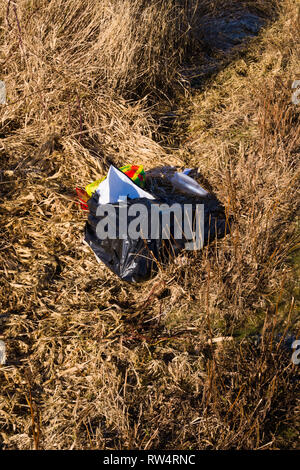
[[0, 0, 300, 449]]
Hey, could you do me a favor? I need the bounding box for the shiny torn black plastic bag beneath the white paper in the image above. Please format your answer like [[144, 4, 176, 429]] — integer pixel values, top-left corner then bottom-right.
[[85, 193, 226, 282]]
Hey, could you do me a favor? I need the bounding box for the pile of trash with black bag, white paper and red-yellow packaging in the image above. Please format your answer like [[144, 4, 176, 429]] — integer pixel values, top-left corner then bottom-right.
[[76, 165, 226, 282]]
